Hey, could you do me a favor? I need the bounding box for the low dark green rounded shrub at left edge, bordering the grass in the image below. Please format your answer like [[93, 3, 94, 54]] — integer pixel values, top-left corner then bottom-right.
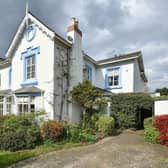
[[1, 131, 26, 152]]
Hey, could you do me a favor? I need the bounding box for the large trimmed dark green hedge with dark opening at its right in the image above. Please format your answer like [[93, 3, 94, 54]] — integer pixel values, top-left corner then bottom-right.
[[111, 93, 153, 129]]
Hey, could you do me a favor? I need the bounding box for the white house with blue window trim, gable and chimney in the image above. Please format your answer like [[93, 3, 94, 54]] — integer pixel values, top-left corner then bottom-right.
[[0, 12, 147, 122]]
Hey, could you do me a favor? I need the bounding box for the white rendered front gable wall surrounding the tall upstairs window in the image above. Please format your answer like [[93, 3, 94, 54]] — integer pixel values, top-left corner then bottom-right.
[[11, 23, 54, 119]]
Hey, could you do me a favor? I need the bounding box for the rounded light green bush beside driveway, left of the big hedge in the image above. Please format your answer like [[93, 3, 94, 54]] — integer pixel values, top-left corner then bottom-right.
[[96, 115, 114, 135]]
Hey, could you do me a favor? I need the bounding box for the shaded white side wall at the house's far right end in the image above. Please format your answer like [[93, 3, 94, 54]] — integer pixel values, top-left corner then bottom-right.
[[134, 60, 146, 92]]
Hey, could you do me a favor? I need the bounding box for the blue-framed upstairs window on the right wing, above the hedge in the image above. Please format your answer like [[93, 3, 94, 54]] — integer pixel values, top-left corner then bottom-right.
[[105, 67, 122, 89]]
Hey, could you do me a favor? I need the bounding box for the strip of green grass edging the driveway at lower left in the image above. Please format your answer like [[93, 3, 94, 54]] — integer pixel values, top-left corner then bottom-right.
[[0, 143, 90, 168]]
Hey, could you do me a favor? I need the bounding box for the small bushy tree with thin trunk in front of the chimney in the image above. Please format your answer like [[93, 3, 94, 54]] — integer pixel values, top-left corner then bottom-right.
[[71, 80, 106, 127]]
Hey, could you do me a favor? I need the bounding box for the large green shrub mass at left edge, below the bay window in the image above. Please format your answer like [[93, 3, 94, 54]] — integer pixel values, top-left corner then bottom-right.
[[0, 115, 42, 151]]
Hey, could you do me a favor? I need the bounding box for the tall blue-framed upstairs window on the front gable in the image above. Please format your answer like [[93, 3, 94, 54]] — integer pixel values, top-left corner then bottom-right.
[[21, 47, 40, 86]]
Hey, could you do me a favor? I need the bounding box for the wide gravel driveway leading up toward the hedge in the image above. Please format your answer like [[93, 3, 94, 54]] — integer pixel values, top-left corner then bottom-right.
[[9, 132, 168, 168]]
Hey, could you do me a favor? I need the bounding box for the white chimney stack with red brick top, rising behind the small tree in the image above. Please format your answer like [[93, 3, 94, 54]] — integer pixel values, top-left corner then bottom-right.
[[67, 18, 84, 122]]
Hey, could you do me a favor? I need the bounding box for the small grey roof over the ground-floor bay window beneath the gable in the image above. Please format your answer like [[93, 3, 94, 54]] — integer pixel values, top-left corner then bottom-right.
[[13, 86, 44, 94]]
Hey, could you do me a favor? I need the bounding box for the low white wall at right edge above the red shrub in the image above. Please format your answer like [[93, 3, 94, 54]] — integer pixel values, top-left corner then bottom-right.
[[154, 100, 168, 115]]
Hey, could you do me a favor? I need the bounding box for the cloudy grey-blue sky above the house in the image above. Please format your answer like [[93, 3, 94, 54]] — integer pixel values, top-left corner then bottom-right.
[[0, 0, 168, 91]]
